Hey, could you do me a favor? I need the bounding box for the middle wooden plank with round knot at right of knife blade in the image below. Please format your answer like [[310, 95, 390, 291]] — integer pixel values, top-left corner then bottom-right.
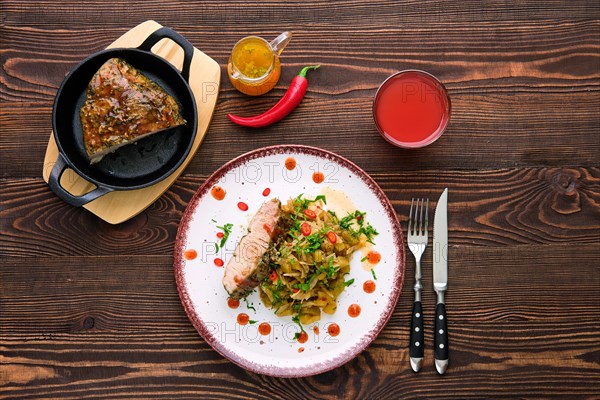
[[0, 168, 600, 257]]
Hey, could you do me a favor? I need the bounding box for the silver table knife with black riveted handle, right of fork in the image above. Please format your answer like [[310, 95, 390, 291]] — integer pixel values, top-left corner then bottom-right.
[[433, 188, 448, 375]]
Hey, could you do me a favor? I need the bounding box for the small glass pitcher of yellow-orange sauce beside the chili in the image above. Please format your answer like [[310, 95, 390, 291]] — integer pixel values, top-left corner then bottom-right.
[[227, 32, 292, 96]]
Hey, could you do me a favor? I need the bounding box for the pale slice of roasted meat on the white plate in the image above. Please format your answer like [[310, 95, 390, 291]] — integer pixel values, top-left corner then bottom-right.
[[223, 199, 281, 299]]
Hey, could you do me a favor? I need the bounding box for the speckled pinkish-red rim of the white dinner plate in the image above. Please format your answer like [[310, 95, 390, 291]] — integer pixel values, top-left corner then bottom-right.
[[174, 144, 406, 378]]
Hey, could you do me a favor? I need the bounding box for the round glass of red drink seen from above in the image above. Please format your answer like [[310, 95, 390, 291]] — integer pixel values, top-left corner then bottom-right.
[[373, 70, 451, 149]]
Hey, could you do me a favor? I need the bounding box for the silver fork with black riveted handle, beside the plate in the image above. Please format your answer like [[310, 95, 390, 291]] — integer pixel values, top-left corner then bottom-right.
[[407, 197, 429, 372]]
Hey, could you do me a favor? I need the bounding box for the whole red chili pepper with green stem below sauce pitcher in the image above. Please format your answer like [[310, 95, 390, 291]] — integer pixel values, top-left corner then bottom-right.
[[227, 65, 319, 128]]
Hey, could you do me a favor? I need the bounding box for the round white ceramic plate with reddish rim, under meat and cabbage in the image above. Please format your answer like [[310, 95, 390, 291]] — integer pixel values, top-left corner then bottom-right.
[[175, 145, 405, 377]]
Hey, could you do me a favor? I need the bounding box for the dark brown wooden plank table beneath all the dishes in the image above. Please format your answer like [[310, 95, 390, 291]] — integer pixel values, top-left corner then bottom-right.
[[0, 0, 600, 399]]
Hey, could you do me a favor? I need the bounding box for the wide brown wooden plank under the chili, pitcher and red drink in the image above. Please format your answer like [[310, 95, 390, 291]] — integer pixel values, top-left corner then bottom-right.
[[0, 19, 600, 177]]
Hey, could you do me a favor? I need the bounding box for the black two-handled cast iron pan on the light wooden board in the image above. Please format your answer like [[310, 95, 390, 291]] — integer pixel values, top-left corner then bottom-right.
[[48, 28, 198, 207]]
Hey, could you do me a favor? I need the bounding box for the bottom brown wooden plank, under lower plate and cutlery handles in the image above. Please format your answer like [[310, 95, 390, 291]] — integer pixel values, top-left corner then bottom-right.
[[0, 245, 600, 399]]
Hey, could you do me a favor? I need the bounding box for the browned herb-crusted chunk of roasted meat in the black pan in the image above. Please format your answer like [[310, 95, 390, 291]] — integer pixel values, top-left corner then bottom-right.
[[79, 58, 185, 164]]
